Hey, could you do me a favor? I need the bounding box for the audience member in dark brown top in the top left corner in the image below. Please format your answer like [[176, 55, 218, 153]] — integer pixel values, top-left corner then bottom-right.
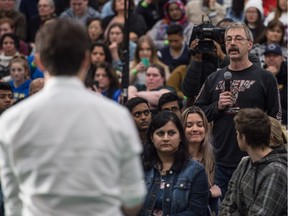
[[0, 0, 27, 40]]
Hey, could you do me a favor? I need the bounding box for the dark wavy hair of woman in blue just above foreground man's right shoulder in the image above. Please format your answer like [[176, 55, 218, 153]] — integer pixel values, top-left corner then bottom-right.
[[91, 62, 119, 98]]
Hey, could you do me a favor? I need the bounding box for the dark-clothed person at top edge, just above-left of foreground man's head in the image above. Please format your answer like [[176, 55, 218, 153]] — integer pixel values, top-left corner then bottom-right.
[[27, 0, 56, 43]]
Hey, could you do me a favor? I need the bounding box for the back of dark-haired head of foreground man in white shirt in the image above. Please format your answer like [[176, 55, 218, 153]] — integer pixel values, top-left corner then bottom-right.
[[36, 19, 89, 76]]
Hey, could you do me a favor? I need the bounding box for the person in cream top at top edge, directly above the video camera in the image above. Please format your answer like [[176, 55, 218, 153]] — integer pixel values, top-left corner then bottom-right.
[[186, 0, 226, 25]]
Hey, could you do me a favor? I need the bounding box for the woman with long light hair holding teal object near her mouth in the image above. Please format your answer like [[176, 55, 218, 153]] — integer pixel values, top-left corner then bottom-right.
[[130, 35, 170, 86]]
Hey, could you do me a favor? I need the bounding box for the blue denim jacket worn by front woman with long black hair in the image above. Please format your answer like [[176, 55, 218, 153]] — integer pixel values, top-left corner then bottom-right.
[[140, 160, 209, 216]]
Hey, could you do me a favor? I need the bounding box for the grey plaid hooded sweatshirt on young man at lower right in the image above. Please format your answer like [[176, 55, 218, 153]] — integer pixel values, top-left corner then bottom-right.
[[220, 147, 287, 216]]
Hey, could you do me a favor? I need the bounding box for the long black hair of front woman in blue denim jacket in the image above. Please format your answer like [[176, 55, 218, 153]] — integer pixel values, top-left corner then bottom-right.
[[143, 111, 189, 171]]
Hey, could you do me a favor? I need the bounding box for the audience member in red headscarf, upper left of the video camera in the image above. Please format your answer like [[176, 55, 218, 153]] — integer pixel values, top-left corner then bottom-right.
[[147, 0, 189, 49]]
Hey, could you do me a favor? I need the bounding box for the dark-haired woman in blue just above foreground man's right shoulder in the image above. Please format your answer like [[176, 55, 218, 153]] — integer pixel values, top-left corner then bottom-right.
[[86, 62, 121, 102]]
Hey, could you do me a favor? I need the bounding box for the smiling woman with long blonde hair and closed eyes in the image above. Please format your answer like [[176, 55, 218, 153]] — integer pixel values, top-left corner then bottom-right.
[[181, 106, 221, 215]]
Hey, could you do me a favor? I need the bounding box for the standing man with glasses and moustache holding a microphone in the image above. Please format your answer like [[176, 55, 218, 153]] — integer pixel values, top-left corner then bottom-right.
[[195, 23, 281, 197]]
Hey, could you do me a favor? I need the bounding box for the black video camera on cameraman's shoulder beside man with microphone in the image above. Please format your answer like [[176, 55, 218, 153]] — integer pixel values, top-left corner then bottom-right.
[[189, 21, 225, 54]]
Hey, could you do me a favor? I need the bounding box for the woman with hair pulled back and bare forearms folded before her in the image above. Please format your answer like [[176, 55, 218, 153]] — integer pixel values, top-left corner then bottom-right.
[[128, 64, 174, 110]]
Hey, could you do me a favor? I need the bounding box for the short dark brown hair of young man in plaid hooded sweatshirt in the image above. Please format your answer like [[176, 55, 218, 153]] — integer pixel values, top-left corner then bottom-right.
[[234, 108, 271, 148]]
